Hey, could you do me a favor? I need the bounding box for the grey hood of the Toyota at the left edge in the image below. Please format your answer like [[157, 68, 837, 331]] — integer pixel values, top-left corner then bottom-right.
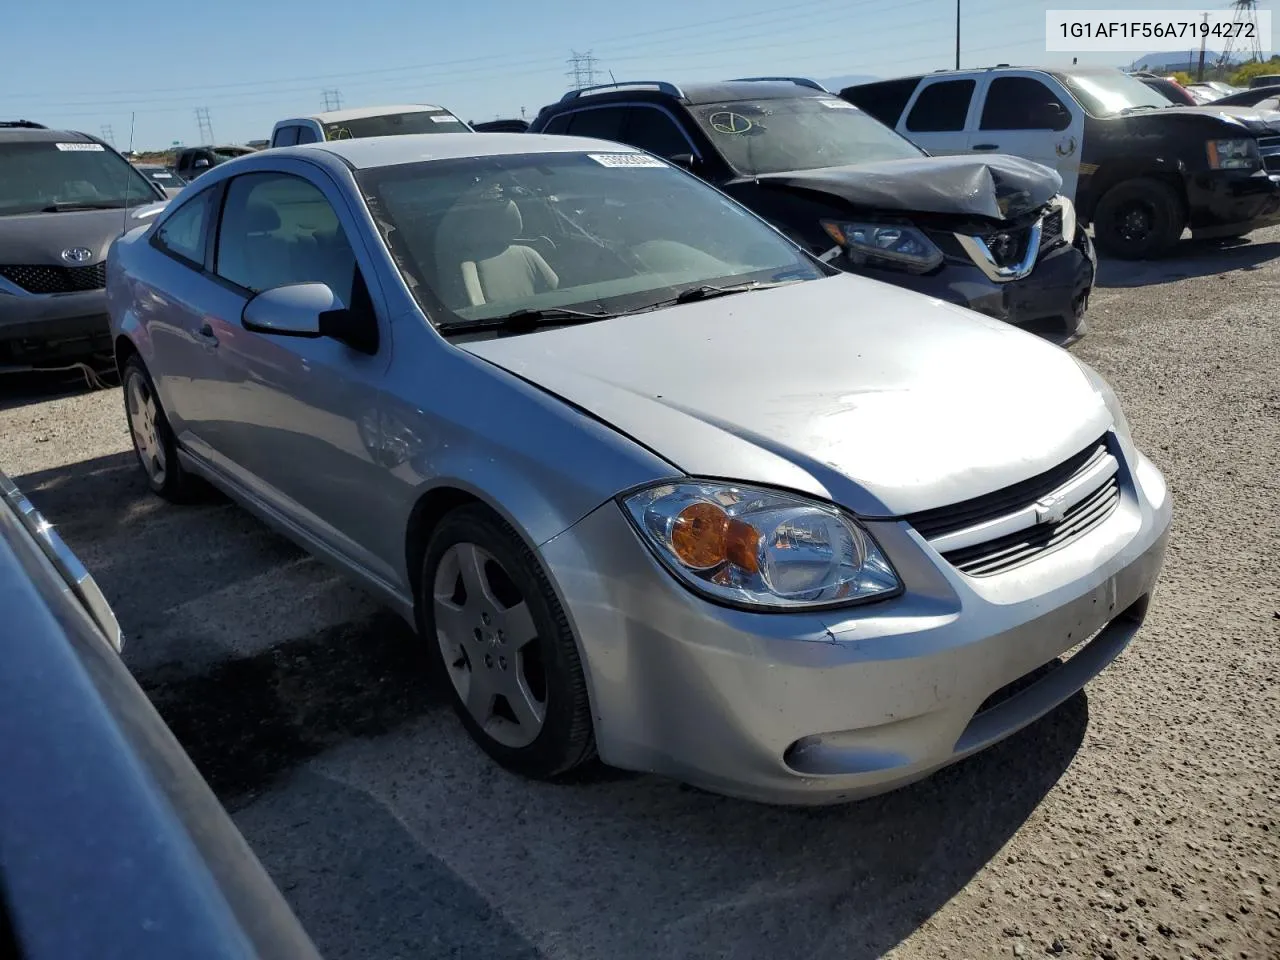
[[0, 201, 165, 266]]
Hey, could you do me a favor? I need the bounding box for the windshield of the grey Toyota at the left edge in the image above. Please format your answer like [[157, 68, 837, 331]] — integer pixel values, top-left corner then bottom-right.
[[0, 140, 156, 216]]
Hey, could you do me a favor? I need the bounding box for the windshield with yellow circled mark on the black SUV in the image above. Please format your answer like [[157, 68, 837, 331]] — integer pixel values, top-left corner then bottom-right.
[[694, 97, 922, 177]]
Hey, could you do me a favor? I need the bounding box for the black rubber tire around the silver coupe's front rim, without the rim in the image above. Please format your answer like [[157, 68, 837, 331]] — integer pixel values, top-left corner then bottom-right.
[[417, 504, 595, 780]]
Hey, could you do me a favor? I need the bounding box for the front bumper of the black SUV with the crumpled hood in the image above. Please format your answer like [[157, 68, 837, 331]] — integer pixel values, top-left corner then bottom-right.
[[831, 228, 1097, 346]]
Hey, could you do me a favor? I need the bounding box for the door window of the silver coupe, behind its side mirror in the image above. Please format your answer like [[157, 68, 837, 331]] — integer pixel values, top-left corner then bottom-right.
[[214, 173, 356, 305]]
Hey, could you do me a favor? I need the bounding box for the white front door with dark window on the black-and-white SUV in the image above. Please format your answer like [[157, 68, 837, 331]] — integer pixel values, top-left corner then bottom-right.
[[969, 73, 1084, 200]]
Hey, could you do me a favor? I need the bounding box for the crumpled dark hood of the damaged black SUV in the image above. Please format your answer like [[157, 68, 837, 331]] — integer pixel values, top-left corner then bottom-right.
[[756, 155, 1062, 220]]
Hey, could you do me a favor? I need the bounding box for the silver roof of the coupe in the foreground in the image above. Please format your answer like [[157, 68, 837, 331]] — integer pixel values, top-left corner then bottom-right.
[[293, 133, 632, 170]]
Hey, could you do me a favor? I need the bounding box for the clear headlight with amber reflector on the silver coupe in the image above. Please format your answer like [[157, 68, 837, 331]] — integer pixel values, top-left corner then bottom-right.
[[622, 480, 901, 611]]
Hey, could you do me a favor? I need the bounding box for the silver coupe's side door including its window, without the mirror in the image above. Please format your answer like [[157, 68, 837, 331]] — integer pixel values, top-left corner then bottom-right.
[[190, 160, 396, 582]]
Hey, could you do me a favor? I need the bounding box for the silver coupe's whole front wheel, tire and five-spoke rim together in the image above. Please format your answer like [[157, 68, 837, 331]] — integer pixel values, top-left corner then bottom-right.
[[417, 504, 595, 780]]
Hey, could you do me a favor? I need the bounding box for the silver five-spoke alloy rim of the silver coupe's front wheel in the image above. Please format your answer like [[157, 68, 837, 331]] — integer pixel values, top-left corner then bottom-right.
[[431, 543, 547, 749]]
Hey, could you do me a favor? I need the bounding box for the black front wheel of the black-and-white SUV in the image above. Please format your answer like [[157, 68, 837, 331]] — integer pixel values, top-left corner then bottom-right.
[[1093, 177, 1187, 260]]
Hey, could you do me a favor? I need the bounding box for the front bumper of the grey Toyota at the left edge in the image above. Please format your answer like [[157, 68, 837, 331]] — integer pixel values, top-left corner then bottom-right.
[[0, 289, 111, 369]]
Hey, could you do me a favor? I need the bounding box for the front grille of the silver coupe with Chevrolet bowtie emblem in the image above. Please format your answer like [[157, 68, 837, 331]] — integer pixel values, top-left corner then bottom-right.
[[905, 436, 1120, 576]]
